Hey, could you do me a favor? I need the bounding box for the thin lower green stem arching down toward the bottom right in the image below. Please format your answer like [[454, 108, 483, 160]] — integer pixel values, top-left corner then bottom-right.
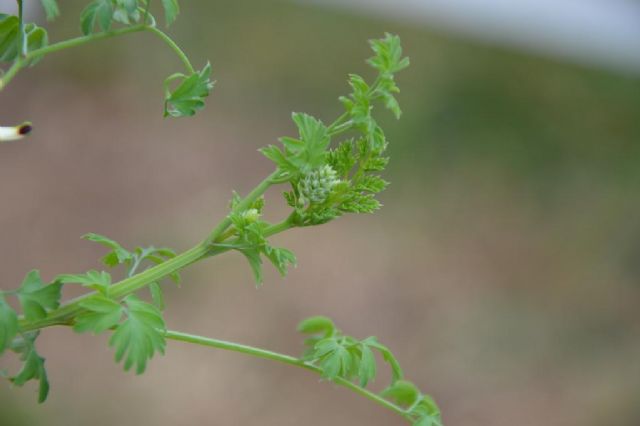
[[165, 330, 409, 419]]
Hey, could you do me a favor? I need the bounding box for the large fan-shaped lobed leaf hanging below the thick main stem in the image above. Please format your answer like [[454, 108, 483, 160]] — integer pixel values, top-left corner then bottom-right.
[[109, 295, 166, 374]]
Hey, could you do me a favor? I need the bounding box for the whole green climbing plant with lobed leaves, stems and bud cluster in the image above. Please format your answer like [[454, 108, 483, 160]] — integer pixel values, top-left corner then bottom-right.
[[0, 0, 442, 426]]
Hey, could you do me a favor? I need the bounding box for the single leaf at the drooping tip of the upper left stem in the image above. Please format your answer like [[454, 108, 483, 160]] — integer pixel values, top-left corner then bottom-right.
[[164, 62, 214, 117]]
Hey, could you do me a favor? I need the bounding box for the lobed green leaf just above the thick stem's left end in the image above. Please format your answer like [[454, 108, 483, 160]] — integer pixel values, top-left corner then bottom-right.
[[17, 270, 62, 321]]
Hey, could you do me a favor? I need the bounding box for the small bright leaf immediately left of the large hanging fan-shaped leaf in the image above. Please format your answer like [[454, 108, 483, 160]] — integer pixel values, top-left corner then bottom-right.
[[73, 296, 124, 334]]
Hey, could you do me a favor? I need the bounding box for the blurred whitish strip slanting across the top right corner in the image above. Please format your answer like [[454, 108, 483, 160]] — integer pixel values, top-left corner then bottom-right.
[[298, 0, 640, 74]]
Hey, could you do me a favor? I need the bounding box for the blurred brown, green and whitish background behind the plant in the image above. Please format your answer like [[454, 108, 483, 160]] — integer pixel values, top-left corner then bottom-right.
[[0, 0, 640, 426]]
